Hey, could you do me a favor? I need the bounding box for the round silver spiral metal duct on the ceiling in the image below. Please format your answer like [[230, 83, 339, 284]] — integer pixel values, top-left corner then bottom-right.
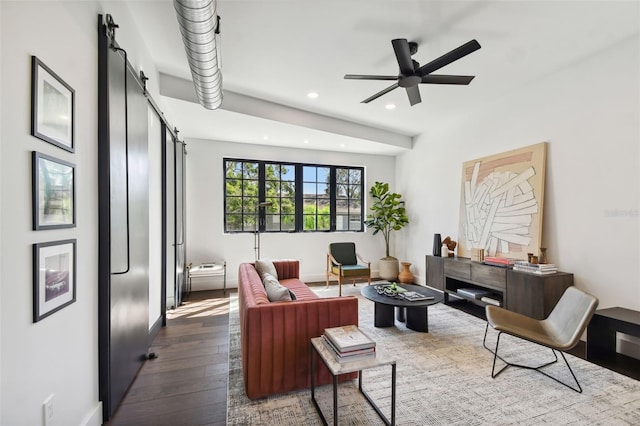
[[173, 0, 222, 109]]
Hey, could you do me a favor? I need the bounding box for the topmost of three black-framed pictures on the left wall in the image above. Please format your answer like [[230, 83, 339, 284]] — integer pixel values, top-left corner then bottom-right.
[[31, 56, 76, 152]]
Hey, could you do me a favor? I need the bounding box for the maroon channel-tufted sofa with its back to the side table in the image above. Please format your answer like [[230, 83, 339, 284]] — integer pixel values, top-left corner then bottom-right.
[[238, 260, 358, 399]]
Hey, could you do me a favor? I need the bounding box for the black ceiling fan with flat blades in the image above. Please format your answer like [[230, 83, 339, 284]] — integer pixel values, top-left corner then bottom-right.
[[344, 38, 480, 106]]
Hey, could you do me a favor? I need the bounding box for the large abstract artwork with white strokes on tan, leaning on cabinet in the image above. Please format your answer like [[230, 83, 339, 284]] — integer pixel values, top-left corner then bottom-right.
[[458, 142, 547, 260]]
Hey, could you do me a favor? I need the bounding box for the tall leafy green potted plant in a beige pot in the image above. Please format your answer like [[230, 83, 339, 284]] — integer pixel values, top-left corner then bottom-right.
[[364, 182, 409, 280]]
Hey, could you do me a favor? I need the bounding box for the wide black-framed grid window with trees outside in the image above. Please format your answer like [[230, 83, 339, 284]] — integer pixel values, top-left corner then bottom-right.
[[224, 159, 364, 232]]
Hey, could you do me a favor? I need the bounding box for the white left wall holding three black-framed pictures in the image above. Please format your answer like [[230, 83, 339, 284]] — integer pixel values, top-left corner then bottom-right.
[[0, 1, 165, 426]]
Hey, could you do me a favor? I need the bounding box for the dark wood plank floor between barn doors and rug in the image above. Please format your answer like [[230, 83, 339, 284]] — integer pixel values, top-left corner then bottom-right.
[[107, 290, 229, 426]]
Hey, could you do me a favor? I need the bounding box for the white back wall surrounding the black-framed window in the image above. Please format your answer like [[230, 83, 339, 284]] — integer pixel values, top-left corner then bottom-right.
[[186, 140, 395, 291]]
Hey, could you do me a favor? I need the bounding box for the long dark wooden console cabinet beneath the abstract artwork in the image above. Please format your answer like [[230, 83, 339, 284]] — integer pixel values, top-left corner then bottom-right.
[[426, 255, 573, 319]]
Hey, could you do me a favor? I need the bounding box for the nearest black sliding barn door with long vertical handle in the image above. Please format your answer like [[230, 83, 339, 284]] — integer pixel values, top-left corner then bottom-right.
[[98, 17, 149, 421]]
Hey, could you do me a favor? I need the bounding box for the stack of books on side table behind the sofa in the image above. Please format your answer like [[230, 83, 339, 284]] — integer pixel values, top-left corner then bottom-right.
[[322, 325, 376, 362]]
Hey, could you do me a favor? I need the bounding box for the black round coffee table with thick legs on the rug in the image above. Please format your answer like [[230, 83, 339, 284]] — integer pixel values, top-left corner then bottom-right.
[[361, 284, 443, 333]]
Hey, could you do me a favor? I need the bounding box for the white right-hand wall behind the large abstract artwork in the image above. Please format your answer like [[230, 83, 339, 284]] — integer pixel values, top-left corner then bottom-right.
[[397, 21, 640, 309]]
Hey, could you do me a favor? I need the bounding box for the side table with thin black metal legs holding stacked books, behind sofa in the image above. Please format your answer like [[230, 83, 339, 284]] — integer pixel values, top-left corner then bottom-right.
[[311, 337, 396, 426]]
